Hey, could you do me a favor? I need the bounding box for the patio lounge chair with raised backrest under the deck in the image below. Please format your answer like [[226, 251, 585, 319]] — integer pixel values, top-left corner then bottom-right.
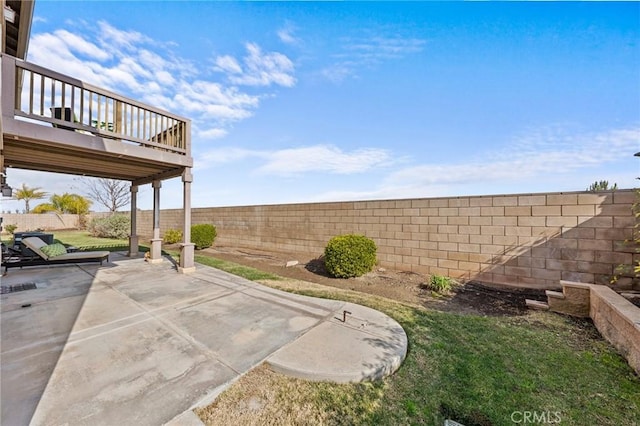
[[2, 237, 109, 271]]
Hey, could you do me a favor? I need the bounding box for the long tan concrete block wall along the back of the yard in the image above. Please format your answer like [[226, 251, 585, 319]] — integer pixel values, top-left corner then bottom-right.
[[138, 190, 638, 288]]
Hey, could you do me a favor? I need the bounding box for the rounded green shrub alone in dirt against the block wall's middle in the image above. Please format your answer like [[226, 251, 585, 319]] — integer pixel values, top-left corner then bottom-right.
[[324, 234, 377, 278]]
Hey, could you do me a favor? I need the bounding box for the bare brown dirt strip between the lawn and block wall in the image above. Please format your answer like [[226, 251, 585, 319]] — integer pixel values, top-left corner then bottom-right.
[[198, 246, 546, 316]]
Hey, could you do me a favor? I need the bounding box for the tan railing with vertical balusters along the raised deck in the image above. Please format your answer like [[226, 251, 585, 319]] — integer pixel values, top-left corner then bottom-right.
[[2, 55, 190, 155]]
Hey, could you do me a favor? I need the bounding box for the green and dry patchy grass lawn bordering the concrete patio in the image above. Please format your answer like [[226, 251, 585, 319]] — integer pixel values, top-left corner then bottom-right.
[[11, 232, 640, 426]]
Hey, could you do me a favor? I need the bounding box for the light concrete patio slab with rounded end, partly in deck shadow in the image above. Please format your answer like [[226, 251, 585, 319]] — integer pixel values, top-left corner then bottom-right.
[[0, 253, 406, 425]]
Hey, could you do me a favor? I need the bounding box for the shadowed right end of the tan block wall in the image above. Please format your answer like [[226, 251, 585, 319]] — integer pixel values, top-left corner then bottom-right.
[[468, 191, 640, 290]]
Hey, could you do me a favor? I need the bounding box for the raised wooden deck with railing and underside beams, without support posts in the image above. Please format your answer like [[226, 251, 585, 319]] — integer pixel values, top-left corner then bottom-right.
[[0, 54, 193, 185]]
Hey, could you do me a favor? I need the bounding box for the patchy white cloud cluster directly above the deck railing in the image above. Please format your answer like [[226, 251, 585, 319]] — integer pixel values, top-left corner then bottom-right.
[[29, 21, 295, 139]]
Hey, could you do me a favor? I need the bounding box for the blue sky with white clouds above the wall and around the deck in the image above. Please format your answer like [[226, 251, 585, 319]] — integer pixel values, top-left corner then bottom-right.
[[3, 0, 640, 210]]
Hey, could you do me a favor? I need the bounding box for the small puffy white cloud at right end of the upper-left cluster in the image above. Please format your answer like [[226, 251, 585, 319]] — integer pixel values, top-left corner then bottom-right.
[[214, 43, 296, 87]]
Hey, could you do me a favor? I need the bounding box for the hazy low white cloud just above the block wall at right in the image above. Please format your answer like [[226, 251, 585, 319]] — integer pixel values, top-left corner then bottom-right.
[[274, 127, 640, 202]]
